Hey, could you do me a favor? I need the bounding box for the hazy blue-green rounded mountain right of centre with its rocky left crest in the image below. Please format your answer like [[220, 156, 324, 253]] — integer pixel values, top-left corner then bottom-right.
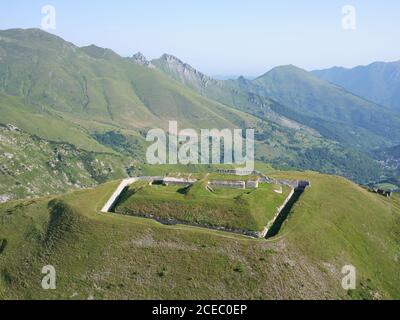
[[153, 52, 400, 148]]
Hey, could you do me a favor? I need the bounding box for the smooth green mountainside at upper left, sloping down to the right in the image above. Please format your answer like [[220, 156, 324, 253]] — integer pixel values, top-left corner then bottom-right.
[[0, 29, 260, 129]]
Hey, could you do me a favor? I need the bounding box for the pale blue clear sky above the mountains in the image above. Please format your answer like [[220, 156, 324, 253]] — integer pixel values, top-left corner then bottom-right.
[[0, 0, 400, 75]]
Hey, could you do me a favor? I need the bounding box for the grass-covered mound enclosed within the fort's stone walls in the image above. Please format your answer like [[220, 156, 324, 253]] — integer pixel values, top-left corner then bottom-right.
[[115, 176, 289, 231]]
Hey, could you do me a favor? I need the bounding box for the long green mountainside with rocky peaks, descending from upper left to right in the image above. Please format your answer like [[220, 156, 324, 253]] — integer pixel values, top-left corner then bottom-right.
[[0, 30, 396, 200]]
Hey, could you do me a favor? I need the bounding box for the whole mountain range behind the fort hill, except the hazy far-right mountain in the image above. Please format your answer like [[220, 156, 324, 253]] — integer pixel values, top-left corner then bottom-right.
[[0, 29, 400, 197]]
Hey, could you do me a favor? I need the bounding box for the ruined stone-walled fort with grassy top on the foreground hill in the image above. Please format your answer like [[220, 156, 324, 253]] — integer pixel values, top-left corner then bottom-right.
[[101, 171, 310, 238]]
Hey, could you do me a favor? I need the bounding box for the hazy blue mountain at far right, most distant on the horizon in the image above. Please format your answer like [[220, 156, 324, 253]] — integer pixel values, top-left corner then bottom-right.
[[312, 61, 400, 112]]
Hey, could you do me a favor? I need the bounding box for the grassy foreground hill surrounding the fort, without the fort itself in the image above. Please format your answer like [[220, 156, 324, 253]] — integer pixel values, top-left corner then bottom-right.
[[0, 173, 400, 299]]
